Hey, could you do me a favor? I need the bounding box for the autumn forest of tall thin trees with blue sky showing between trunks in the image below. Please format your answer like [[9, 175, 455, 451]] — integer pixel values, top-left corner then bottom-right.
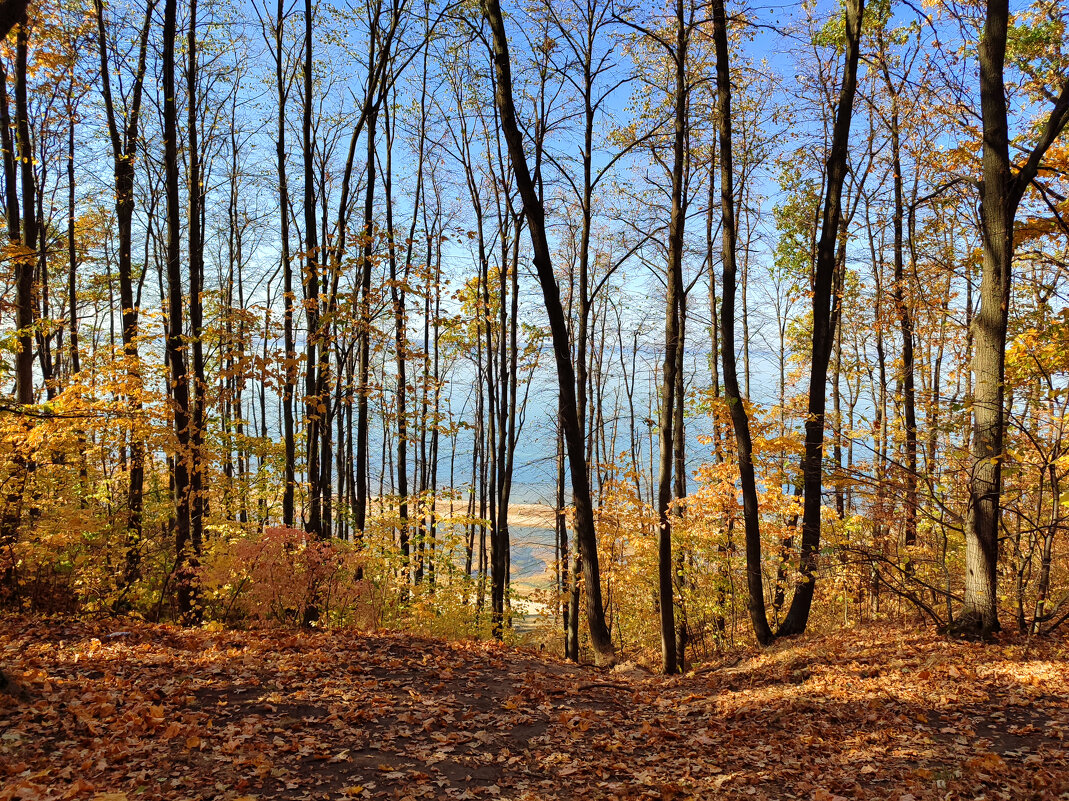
[[0, 0, 1069, 714]]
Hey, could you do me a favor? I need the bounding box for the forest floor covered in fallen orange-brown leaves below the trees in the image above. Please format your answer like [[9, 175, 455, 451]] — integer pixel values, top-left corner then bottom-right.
[[0, 617, 1069, 801]]
